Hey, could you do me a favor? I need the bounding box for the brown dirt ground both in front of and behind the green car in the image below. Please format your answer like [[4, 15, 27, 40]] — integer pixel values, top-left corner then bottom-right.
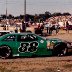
[[0, 31, 72, 72]]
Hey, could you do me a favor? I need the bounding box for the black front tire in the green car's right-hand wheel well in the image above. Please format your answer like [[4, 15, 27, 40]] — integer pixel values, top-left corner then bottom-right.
[[53, 43, 68, 56]]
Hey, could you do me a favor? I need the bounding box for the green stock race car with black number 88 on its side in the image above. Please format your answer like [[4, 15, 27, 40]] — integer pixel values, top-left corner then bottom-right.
[[0, 33, 71, 58]]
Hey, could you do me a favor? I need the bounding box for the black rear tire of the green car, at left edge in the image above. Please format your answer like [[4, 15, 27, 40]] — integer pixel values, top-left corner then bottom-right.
[[0, 46, 11, 59]]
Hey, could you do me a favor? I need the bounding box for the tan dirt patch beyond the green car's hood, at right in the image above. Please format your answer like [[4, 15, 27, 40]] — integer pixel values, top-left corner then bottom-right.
[[47, 30, 72, 42]]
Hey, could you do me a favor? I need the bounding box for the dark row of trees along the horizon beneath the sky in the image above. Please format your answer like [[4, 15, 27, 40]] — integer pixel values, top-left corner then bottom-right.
[[0, 11, 71, 22]]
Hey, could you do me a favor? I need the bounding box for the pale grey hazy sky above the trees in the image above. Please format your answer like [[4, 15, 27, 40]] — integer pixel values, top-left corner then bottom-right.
[[0, 0, 72, 16]]
